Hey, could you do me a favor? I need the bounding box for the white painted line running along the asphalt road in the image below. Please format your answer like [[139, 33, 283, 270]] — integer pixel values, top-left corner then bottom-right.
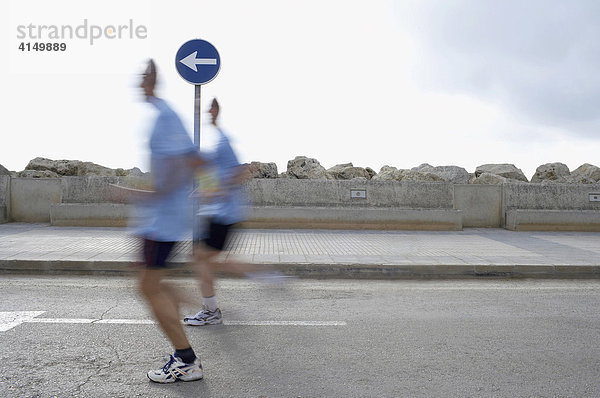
[[0, 311, 348, 332]]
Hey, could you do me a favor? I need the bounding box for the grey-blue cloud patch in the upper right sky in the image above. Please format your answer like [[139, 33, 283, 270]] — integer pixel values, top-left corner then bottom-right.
[[398, 0, 600, 138]]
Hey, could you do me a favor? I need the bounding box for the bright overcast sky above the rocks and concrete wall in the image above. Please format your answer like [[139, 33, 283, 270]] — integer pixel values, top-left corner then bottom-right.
[[0, 0, 600, 177]]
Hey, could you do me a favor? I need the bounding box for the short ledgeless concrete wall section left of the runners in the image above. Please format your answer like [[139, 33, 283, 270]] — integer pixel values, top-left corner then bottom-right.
[[10, 178, 62, 222]]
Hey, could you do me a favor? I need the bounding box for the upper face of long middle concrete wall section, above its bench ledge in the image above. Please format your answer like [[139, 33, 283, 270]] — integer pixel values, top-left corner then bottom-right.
[[247, 178, 453, 209]]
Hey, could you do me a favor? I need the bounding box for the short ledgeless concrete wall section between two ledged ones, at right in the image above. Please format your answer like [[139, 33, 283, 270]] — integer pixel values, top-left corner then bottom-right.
[[454, 184, 504, 228]]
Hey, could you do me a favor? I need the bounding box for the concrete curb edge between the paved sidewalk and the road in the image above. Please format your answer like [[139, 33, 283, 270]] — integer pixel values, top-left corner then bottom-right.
[[0, 260, 600, 280]]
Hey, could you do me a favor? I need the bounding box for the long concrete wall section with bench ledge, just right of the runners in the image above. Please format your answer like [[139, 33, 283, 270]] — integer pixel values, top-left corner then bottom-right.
[[243, 179, 462, 230]]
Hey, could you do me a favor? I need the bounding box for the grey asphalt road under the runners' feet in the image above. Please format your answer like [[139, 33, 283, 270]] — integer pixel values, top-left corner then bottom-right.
[[0, 276, 600, 397]]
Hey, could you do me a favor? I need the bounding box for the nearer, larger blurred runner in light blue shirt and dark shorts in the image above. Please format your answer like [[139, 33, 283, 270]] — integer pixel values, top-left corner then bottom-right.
[[136, 60, 203, 383]]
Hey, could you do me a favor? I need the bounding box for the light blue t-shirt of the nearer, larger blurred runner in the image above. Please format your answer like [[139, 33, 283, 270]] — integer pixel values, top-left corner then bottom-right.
[[134, 97, 198, 242]]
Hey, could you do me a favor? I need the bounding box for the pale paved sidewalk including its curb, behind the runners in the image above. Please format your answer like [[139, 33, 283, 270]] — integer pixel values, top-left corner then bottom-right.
[[0, 223, 600, 279]]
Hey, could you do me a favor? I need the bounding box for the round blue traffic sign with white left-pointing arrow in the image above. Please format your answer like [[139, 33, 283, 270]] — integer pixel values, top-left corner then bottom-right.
[[175, 39, 221, 85]]
